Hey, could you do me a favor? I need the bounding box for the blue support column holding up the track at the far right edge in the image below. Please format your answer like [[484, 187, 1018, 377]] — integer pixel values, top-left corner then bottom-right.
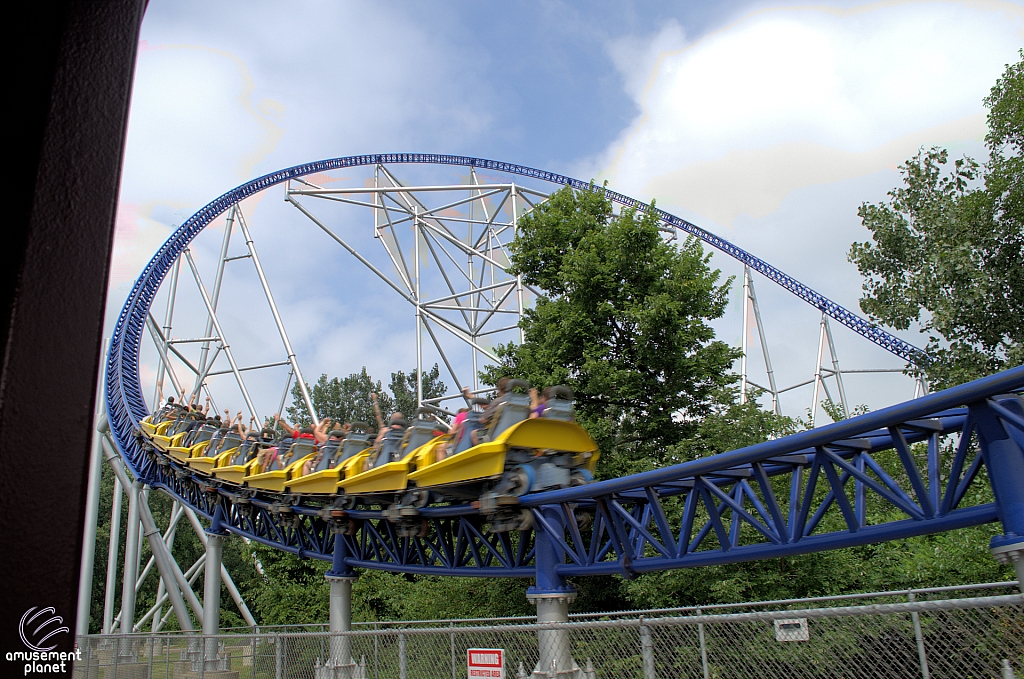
[[971, 395, 1024, 592]]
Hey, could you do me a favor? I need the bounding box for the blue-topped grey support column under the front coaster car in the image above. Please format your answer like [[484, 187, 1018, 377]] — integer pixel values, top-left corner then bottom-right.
[[526, 505, 584, 679]]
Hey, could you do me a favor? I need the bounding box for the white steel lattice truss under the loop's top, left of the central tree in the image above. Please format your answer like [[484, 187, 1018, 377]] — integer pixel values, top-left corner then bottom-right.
[[286, 165, 547, 410]]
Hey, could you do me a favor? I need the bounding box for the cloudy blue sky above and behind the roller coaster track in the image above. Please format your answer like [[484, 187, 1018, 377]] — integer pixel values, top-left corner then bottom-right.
[[108, 0, 1024, 426]]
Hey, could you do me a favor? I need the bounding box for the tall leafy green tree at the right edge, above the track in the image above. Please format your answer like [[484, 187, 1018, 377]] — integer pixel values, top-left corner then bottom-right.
[[849, 50, 1024, 387]]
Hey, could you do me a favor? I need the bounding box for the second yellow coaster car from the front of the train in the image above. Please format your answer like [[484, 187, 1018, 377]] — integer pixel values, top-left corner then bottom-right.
[[338, 412, 437, 500]]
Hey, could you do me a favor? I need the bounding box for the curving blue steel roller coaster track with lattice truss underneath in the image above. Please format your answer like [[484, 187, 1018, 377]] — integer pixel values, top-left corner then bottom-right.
[[105, 154, 1024, 577]]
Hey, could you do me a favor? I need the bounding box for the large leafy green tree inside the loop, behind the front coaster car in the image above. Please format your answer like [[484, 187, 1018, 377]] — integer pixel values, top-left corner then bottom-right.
[[484, 187, 738, 474]]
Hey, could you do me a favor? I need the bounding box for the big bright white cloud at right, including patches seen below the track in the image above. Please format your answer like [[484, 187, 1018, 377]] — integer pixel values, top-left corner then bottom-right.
[[580, 2, 1024, 414]]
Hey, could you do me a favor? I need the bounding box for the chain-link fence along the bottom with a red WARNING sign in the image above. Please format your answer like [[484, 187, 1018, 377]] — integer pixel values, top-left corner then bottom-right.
[[75, 584, 1024, 679]]
